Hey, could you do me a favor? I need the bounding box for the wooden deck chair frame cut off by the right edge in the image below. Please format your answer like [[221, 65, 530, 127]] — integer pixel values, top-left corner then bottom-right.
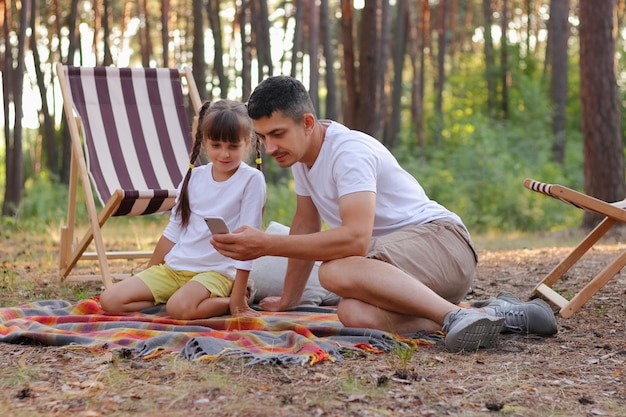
[[524, 178, 626, 318]]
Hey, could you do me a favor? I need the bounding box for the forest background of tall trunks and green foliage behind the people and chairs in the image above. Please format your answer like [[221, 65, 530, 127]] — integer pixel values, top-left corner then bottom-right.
[[0, 0, 626, 233]]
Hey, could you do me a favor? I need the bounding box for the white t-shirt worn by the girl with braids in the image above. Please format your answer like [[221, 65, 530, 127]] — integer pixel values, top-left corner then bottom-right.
[[163, 162, 266, 279]]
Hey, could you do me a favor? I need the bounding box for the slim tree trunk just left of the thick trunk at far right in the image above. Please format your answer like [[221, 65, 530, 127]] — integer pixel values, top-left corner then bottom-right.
[[548, 0, 569, 165]]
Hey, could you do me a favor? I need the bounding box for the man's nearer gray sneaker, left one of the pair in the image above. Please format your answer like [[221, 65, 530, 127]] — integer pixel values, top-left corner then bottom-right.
[[442, 308, 504, 352]]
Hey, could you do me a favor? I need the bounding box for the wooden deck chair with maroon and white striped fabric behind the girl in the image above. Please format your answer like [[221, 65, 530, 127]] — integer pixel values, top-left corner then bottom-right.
[[56, 64, 202, 287]]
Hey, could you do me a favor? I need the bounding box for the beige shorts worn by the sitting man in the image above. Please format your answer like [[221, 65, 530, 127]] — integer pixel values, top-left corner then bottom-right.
[[366, 221, 478, 303]]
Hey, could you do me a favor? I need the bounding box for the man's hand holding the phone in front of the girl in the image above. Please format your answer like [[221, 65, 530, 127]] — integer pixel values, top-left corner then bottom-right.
[[211, 226, 267, 261]]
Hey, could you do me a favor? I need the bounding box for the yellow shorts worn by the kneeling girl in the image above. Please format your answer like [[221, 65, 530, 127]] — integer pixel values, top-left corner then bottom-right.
[[137, 264, 234, 305]]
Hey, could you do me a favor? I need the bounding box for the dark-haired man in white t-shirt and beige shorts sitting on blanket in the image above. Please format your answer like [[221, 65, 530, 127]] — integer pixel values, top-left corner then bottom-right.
[[212, 76, 556, 352]]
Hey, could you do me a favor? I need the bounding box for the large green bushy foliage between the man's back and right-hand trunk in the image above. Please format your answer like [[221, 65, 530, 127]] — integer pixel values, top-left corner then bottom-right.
[[395, 72, 582, 232]]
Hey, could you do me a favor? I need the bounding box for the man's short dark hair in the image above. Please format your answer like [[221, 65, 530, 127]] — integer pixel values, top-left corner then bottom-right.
[[248, 75, 315, 121]]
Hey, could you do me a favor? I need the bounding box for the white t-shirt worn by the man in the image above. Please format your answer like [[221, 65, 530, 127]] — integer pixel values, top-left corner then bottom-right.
[[292, 120, 465, 237]]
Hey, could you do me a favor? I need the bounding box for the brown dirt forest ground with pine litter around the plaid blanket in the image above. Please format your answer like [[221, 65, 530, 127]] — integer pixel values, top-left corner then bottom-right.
[[0, 229, 626, 417]]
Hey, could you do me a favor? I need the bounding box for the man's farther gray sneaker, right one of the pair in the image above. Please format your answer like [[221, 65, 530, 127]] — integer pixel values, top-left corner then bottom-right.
[[483, 291, 557, 336]]
